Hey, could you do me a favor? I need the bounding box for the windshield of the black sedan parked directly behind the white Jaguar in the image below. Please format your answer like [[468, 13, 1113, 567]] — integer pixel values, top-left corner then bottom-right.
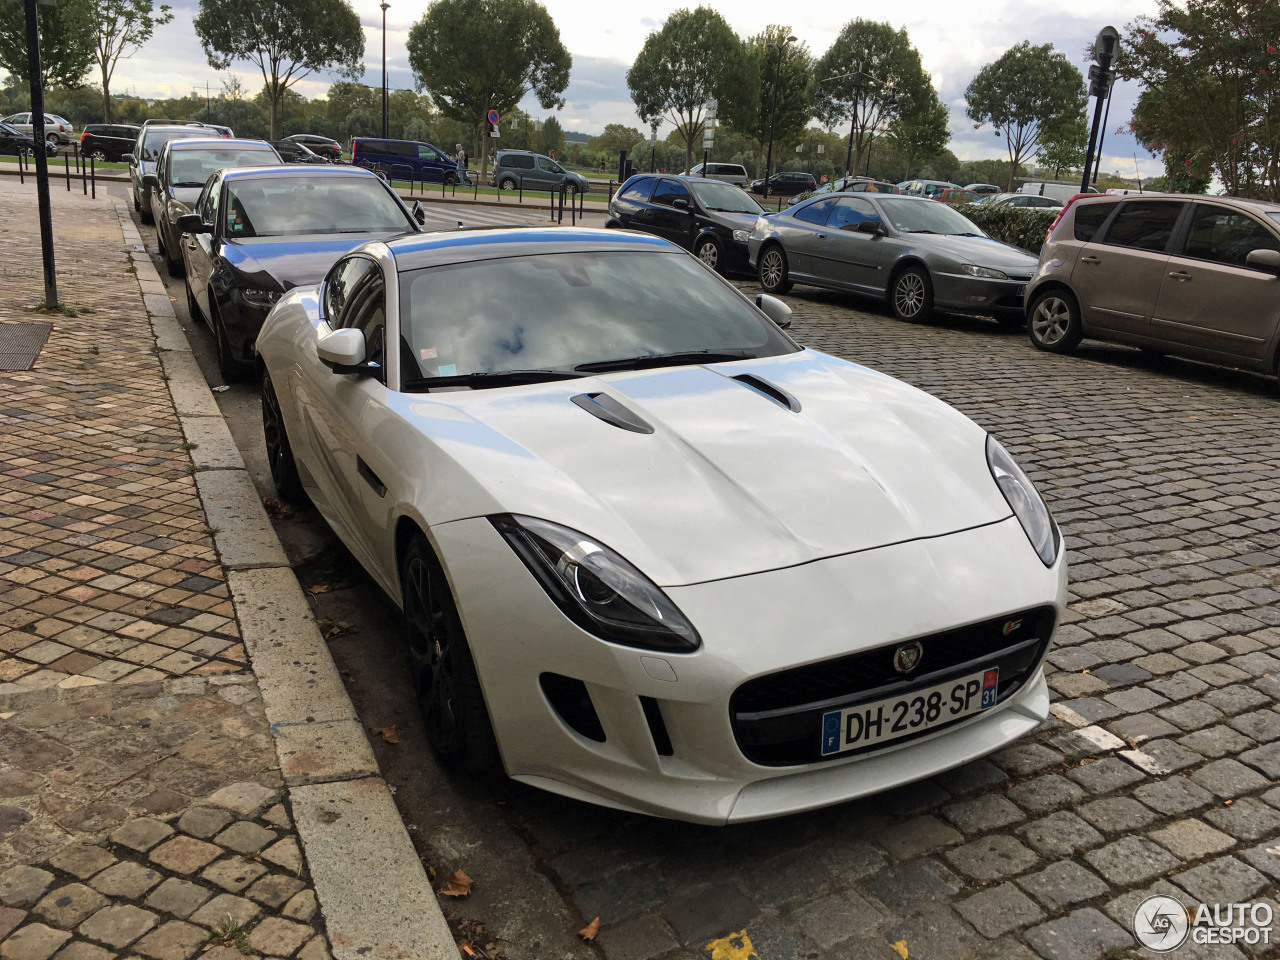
[[225, 174, 413, 239]]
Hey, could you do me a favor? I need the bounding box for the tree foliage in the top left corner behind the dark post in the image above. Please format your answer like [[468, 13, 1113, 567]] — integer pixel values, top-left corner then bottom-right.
[[0, 0, 93, 90]]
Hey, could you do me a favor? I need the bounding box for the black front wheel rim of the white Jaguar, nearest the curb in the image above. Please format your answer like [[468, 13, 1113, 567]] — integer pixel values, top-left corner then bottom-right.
[[404, 557, 456, 745]]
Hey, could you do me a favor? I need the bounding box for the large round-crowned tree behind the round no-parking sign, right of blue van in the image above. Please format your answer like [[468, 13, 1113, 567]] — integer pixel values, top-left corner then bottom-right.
[[408, 0, 573, 179]]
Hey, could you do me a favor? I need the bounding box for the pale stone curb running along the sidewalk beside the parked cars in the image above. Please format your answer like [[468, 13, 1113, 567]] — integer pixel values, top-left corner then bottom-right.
[[115, 207, 458, 960]]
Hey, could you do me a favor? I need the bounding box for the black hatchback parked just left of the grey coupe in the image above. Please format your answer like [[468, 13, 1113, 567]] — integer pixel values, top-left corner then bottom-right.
[[605, 174, 764, 273]]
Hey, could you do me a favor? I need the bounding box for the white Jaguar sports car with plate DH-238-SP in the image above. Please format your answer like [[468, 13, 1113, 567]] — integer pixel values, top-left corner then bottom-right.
[[257, 228, 1066, 823]]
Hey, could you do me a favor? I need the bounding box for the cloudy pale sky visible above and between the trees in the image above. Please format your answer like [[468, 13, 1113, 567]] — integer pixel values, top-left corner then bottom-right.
[[113, 0, 1162, 177]]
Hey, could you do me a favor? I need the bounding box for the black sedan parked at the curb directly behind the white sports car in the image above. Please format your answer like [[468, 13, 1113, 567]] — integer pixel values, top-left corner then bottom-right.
[[177, 164, 425, 380]]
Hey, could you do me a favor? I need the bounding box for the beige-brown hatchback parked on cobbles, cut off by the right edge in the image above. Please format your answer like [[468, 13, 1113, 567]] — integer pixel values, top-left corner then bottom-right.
[[1024, 195, 1280, 374]]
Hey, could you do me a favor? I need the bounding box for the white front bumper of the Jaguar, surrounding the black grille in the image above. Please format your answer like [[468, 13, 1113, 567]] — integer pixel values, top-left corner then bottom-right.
[[431, 517, 1066, 824]]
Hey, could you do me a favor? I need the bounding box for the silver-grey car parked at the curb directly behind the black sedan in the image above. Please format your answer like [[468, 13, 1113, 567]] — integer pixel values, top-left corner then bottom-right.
[[142, 137, 280, 276]]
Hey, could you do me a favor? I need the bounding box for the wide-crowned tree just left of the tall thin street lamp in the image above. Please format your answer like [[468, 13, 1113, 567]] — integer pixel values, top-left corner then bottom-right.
[[193, 0, 365, 140]]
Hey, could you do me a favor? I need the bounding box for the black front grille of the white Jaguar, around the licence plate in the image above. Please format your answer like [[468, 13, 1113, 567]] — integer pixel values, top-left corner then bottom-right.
[[730, 607, 1056, 767]]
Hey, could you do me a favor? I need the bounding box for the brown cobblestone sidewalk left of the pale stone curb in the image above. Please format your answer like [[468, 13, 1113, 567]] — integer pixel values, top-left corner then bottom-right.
[[0, 178, 329, 960]]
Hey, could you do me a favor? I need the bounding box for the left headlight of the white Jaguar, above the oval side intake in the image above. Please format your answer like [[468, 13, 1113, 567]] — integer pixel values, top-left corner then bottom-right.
[[489, 515, 701, 653]]
